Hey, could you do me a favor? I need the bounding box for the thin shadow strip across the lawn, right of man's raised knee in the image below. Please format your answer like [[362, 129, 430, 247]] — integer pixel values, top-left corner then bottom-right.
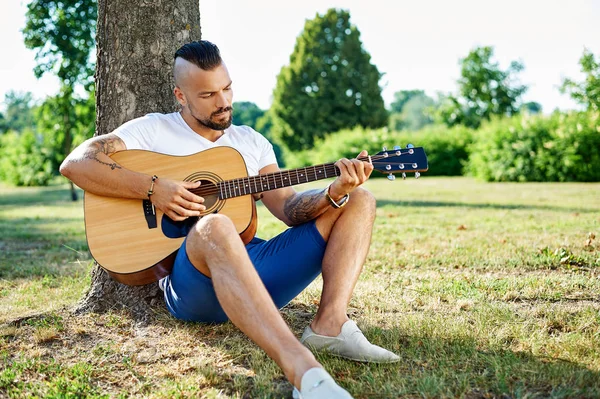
[[377, 200, 598, 213]]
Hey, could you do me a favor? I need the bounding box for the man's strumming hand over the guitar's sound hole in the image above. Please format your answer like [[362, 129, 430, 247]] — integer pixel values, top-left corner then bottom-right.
[[150, 177, 206, 222]]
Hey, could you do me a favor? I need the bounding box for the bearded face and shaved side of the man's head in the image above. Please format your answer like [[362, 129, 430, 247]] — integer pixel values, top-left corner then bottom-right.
[[175, 59, 233, 130]]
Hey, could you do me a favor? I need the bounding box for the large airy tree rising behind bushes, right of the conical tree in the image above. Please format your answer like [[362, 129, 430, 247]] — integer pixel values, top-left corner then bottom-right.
[[438, 46, 527, 128]]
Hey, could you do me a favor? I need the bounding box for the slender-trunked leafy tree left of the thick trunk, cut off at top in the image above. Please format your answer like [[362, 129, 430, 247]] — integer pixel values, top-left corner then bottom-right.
[[23, 0, 97, 201]]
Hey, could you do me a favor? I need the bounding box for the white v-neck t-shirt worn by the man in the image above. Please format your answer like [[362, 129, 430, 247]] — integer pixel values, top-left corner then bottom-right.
[[114, 112, 277, 176]]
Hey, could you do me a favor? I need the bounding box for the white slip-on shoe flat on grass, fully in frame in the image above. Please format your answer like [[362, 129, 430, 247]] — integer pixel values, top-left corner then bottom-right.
[[300, 320, 400, 363]]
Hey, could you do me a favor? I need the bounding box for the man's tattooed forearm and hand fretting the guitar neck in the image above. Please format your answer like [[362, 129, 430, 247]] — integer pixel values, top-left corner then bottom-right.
[[260, 151, 373, 226]]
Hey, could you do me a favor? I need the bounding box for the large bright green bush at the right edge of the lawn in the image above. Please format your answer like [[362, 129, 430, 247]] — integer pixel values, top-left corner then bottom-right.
[[467, 112, 600, 182]]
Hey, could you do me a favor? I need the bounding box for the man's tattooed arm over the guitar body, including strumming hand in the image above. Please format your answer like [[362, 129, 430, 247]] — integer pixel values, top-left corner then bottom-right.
[[60, 133, 205, 220]]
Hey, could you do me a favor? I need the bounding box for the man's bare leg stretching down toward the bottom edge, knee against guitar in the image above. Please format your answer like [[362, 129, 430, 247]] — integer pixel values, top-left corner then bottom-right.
[[186, 214, 321, 389]]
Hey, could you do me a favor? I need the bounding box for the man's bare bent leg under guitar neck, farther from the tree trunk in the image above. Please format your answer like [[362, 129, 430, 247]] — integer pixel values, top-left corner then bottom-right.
[[311, 188, 376, 337]]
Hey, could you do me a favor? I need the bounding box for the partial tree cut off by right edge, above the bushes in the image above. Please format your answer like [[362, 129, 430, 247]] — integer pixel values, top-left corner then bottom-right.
[[561, 49, 600, 111]]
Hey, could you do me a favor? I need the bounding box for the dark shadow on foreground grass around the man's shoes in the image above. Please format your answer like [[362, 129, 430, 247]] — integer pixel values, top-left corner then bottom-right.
[[146, 316, 600, 399]]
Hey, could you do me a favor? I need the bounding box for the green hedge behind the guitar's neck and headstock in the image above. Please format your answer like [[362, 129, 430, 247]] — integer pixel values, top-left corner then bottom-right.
[[284, 126, 473, 176]]
